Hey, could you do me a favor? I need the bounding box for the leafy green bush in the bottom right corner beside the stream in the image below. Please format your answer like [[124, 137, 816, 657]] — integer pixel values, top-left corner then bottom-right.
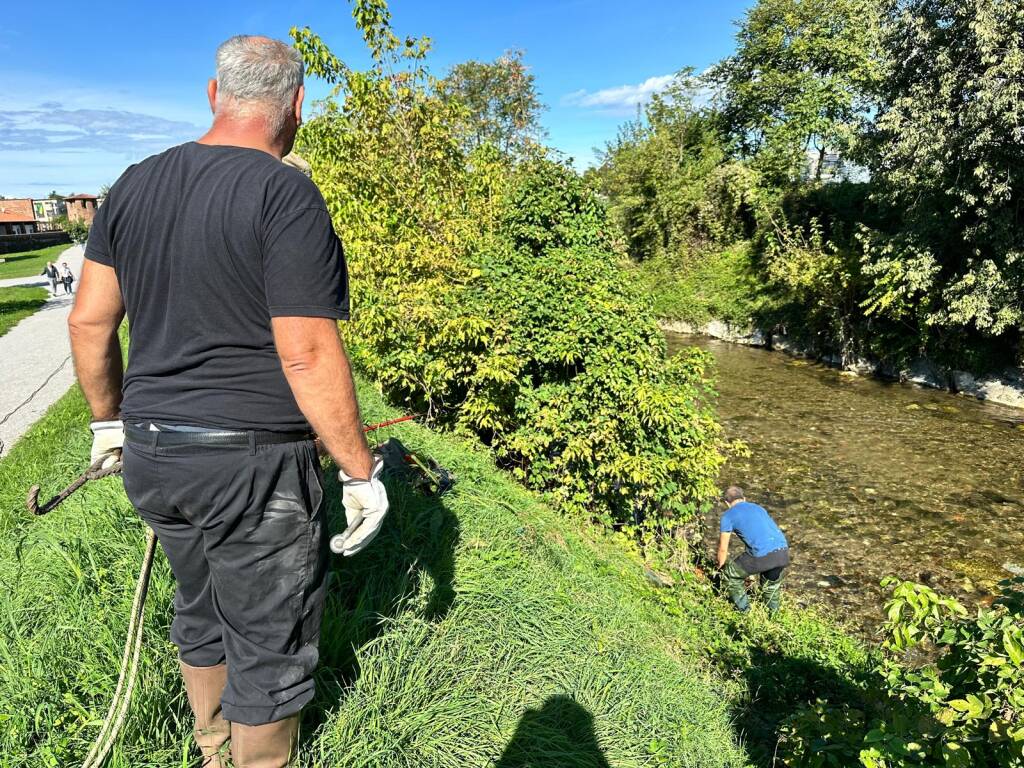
[[782, 578, 1024, 768]]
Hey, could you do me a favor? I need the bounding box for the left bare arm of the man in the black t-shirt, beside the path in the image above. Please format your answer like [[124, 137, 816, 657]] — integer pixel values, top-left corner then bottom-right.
[[68, 260, 125, 421]]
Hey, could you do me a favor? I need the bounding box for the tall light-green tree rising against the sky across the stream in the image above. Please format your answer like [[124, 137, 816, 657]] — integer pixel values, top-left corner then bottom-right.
[[710, 0, 879, 181]]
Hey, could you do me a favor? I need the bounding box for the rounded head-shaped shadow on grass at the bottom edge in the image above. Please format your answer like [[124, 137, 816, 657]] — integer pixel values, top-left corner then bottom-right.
[[494, 694, 609, 768]]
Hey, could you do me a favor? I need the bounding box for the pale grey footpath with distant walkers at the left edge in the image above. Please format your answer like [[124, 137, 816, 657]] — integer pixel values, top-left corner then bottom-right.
[[0, 246, 83, 456]]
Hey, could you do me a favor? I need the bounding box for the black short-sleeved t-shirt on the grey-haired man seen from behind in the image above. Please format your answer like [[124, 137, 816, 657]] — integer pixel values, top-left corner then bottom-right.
[[85, 142, 348, 431]]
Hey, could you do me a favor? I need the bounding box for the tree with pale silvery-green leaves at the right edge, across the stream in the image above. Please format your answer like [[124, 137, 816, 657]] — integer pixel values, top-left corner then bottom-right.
[[864, 0, 1024, 354]]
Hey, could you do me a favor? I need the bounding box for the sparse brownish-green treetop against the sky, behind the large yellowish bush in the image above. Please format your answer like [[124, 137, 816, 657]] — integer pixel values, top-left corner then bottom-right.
[[437, 50, 544, 157]]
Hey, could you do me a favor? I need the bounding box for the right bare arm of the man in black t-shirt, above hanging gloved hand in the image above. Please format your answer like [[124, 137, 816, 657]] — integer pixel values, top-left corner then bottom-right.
[[270, 317, 373, 478]]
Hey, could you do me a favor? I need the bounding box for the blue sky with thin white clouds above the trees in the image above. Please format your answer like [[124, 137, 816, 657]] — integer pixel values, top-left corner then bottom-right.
[[0, 0, 752, 197]]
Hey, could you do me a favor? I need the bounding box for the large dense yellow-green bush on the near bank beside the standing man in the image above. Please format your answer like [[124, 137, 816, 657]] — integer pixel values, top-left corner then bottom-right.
[[293, 0, 724, 530]]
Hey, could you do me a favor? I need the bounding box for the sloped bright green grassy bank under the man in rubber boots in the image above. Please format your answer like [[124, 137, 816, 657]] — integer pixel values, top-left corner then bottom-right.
[[0, 385, 863, 768]]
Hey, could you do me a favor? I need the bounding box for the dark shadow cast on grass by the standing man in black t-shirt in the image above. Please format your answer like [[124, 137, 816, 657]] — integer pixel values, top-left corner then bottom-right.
[[306, 456, 459, 733]]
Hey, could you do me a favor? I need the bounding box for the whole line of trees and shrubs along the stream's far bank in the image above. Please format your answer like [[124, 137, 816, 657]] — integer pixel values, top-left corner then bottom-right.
[[591, 0, 1024, 370]]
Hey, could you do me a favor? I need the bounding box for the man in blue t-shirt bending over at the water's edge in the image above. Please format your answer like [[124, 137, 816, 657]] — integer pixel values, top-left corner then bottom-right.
[[718, 485, 790, 613]]
